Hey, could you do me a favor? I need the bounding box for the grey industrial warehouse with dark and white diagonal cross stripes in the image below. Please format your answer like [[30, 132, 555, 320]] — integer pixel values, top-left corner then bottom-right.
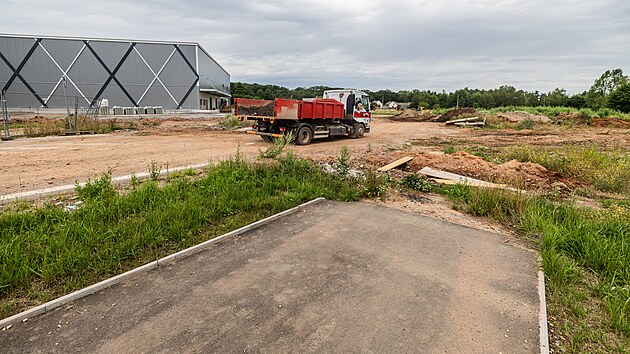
[[0, 34, 230, 110]]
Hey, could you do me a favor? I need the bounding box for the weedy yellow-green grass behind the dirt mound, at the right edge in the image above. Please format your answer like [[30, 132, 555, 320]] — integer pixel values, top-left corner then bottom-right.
[[499, 144, 630, 195]]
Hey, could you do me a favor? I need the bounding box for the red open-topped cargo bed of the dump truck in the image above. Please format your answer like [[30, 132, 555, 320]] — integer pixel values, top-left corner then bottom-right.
[[234, 98, 345, 120]]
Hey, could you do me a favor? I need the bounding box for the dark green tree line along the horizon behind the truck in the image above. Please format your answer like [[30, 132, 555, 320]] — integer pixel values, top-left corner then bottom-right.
[[231, 69, 630, 113]]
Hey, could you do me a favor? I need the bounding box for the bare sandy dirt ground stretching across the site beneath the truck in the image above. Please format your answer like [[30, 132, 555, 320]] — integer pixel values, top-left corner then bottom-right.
[[0, 117, 630, 195]]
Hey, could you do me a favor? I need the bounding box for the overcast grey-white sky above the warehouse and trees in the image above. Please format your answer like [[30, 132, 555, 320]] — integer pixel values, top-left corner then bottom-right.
[[0, 0, 630, 93]]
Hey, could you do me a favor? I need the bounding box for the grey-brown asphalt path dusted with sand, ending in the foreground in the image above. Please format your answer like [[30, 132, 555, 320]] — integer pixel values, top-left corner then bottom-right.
[[0, 201, 539, 353]]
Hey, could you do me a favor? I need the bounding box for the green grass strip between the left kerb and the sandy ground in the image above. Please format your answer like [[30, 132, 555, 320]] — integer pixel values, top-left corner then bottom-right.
[[0, 154, 359, 318]]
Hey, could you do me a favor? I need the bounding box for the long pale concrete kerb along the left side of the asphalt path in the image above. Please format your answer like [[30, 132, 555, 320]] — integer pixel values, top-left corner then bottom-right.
[[0, 197, 326, 328]]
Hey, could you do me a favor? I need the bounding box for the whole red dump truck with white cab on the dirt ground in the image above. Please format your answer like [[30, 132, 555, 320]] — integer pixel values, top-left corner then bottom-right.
[[234, 89, 372, 145]]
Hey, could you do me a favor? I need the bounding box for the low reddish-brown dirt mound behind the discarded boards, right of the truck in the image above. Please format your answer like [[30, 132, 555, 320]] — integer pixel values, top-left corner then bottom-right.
[[367, 151, 572, 190]]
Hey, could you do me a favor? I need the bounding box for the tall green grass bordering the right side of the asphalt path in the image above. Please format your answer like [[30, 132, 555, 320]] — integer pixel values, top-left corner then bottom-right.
[[442, 185, 630, 352]]
